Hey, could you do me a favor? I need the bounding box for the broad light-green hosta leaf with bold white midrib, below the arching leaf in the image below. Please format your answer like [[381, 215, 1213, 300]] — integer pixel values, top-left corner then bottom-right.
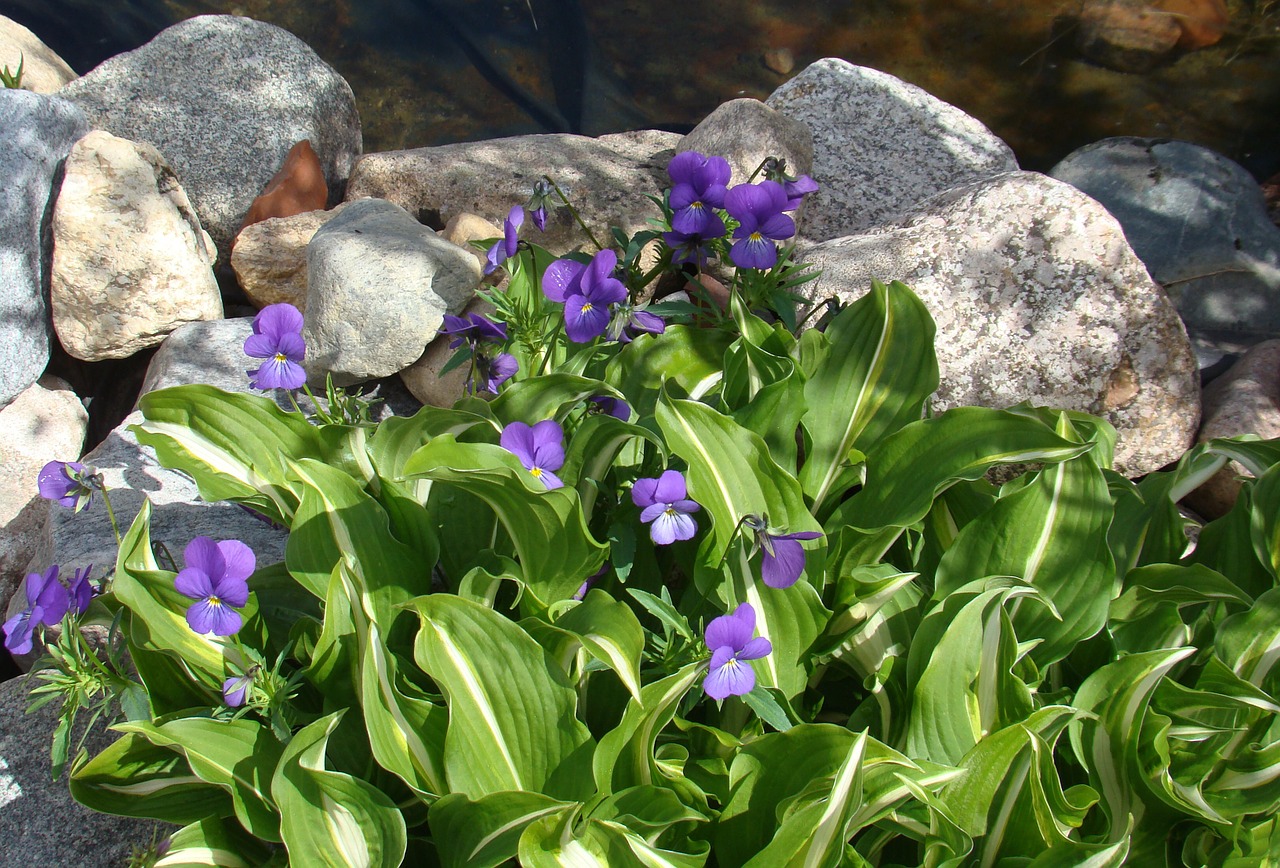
[[411, 594, 595, 799]]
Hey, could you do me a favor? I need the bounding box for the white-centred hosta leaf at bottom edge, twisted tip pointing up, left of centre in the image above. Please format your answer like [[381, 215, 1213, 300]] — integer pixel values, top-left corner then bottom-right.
[[271, 712, 407, 868]]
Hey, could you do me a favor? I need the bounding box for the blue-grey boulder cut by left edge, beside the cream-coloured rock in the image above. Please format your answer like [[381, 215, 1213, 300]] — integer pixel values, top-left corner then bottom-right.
[[0, 88, 88, 407]]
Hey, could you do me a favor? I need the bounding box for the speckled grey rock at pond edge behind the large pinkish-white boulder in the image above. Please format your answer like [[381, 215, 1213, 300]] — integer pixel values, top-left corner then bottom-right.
[[765, 58, 1018, 242]]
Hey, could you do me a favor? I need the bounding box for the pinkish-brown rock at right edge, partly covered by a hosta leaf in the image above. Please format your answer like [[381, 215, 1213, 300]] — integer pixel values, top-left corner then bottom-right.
[[1187, 341, 1280, 518]]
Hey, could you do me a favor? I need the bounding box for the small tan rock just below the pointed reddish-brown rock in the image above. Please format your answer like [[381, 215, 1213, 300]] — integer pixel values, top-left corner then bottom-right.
[[232, 202, 346, 311]]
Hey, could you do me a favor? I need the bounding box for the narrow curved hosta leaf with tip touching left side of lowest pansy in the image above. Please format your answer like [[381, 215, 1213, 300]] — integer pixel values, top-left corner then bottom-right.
[[591, 662, 705, 795]]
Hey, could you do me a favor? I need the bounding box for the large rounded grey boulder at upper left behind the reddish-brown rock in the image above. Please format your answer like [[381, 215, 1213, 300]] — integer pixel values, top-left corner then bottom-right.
[[60, 15, 362, 264]]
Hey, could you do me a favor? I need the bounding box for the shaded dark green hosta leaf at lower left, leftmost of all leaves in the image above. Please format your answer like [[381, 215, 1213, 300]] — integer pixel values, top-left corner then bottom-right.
[[70, 732, 232, 823]]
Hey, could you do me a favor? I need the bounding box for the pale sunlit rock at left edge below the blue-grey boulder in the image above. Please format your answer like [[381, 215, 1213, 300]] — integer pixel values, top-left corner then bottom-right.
[[0, 374, 88, 609]]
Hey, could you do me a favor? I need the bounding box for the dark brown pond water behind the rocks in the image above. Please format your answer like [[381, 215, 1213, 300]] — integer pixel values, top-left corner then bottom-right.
[[0, 0, 1280, 179]]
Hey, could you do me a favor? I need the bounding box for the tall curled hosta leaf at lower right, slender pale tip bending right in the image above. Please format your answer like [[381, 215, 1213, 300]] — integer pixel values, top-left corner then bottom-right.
[[1069, 648, 1196, 864]]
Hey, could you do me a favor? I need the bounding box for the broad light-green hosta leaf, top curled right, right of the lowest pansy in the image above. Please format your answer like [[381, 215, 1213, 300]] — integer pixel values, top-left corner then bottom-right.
[[906, 583, 1034, 764]]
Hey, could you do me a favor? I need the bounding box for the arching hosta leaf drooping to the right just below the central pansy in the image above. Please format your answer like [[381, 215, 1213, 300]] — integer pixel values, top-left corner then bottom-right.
[[404, 434, 608, 609]]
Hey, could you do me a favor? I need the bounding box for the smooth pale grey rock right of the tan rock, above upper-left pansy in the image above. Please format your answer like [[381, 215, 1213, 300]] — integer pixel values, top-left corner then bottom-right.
[[302, 198, 480, 385]]
